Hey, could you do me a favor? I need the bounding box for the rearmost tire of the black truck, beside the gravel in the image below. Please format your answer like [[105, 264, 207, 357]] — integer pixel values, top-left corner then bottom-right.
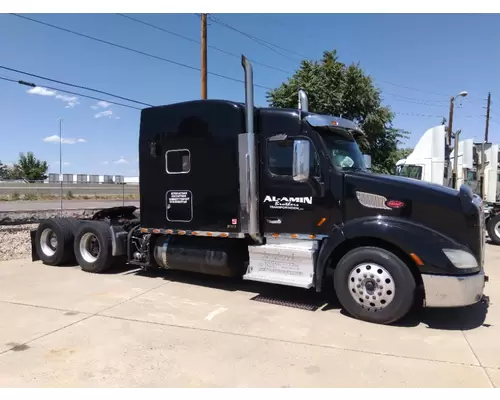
[[35, 218, 76, 266]]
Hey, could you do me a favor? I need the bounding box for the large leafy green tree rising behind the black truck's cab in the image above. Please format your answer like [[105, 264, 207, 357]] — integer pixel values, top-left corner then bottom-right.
[[267, 50, 408, 173]]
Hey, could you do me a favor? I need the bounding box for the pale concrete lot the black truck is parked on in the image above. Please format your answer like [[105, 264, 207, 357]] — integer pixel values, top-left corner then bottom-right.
[[0, 246, 500, 387]]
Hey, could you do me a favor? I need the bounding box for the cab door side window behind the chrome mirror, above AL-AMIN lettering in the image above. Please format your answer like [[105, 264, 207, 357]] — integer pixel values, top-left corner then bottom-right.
[[267, 138, 321, 178]]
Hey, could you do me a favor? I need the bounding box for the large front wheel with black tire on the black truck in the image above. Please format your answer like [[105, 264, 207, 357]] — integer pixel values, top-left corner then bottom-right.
[[334, 247, 416, 324]]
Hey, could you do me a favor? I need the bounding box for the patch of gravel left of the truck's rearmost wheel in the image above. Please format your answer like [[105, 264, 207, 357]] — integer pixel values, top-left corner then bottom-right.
[[0, 224, 38, 261]]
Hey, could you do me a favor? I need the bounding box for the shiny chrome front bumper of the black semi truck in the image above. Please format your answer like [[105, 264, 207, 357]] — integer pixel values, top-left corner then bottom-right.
[[422, 271, 486, 307]]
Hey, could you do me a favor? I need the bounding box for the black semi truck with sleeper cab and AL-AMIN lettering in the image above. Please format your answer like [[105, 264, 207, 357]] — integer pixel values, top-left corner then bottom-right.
[[31, 56, 487, 324]]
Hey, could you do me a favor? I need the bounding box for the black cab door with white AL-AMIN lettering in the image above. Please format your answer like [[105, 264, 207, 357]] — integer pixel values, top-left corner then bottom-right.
[[259, 135, 334, 235]]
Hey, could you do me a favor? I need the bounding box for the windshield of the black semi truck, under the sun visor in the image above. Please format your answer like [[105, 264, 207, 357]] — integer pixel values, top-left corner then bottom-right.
[[319, 130, 367, 171]]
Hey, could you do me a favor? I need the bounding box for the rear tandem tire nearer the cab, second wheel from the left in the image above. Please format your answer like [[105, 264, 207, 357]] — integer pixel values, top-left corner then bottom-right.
[[74, 221, 114, 274]]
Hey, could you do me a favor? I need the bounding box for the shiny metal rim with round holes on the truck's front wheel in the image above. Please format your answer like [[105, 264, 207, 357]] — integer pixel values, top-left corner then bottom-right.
[[348, 263, 396, 312]]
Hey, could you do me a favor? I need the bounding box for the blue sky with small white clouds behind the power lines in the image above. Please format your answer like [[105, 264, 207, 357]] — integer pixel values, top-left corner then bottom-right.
[[0, 14, 500, 176]]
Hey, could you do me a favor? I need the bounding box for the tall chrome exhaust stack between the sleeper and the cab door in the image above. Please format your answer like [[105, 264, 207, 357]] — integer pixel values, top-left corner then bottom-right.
[[238, 55, 260, 241]]
